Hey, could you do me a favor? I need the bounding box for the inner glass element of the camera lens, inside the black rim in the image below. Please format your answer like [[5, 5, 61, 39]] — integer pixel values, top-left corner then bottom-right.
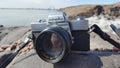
[[41, 33, 63, 59]]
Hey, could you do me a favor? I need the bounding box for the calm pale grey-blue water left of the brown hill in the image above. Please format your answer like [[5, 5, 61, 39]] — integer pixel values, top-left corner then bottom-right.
[[0, 9, 54, 26]]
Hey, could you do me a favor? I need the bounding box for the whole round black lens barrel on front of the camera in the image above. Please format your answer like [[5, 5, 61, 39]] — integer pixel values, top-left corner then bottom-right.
[[35, 27, 72, 63]]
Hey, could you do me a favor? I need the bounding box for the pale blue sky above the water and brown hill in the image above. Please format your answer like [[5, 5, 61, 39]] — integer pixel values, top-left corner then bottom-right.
[[0, 0, 120, 8]]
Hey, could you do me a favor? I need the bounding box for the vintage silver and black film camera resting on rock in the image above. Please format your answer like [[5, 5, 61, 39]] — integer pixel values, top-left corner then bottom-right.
[[31, 11, 90, 63]]
